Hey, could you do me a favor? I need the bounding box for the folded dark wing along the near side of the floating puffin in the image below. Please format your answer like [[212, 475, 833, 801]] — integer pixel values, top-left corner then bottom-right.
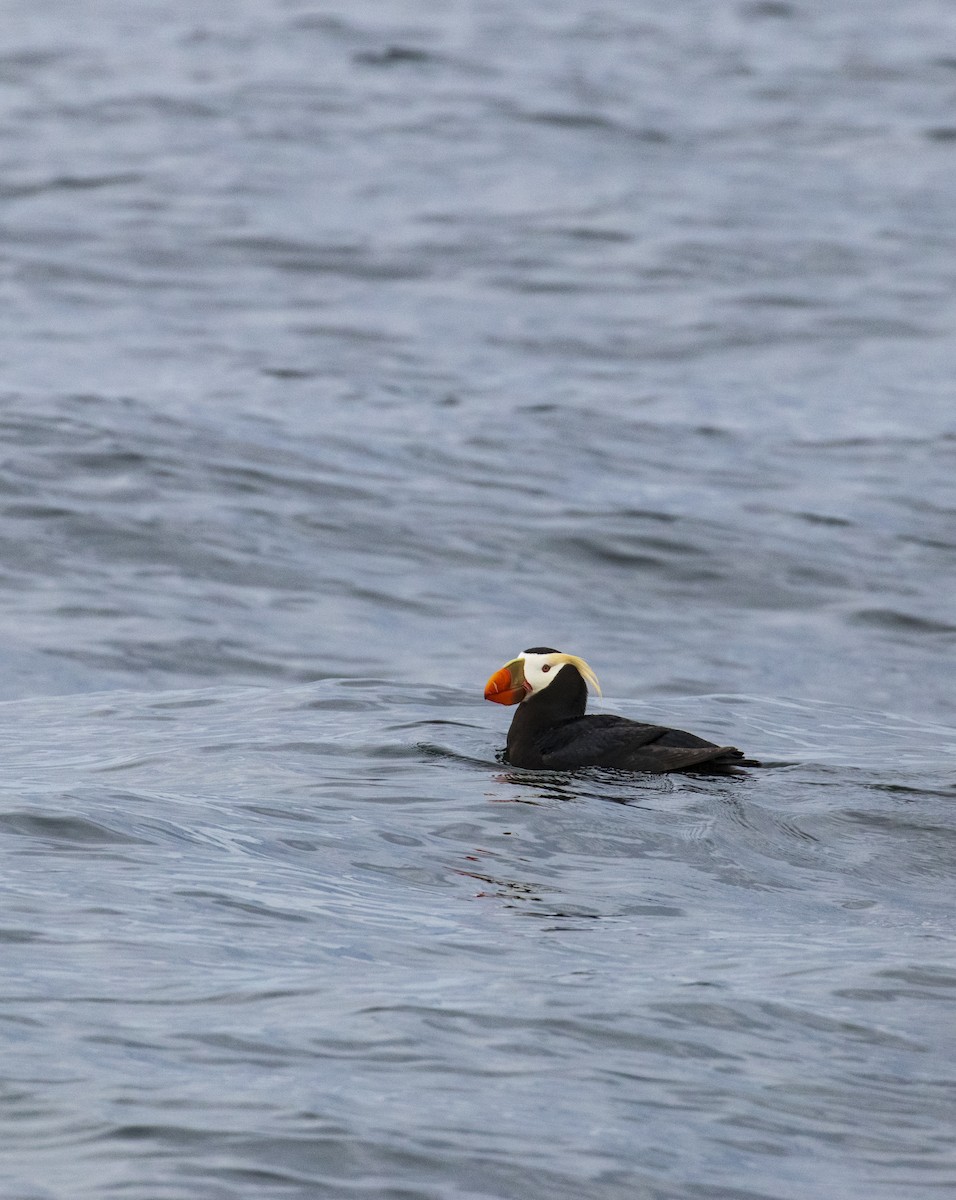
[[537, 714, 746, 773]]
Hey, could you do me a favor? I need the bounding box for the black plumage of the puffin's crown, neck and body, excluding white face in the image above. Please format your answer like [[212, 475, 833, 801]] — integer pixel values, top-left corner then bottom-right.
[[496, 648, 759, 773]]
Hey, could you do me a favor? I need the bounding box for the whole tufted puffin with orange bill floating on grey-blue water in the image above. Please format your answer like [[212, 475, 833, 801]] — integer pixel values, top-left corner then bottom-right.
[[485, 646, 759, 773]]
